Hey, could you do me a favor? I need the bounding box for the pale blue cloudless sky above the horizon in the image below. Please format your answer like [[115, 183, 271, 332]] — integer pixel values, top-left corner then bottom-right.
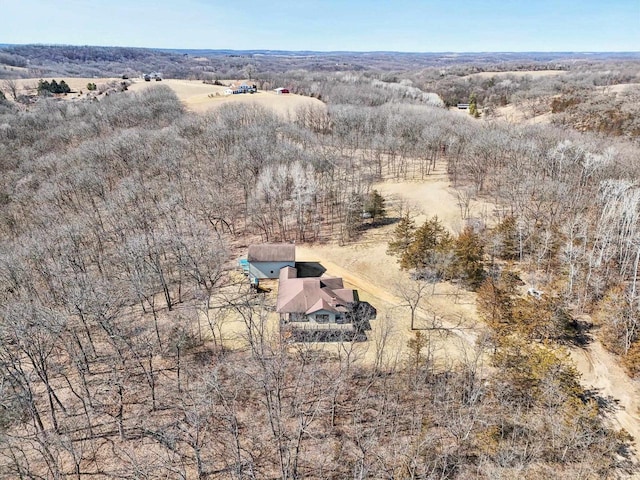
[[5, 0, 640, 52]]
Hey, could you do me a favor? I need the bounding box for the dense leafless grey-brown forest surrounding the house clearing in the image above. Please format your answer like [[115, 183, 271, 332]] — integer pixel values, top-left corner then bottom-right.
[[0, 47, 640, 479]]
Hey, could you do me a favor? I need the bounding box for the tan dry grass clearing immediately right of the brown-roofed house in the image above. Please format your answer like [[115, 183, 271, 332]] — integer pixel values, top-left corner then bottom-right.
[[296, 242, 477, 365]]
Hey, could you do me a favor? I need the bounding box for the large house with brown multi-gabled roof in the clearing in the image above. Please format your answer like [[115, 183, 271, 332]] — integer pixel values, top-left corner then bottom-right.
[[276, 267, 358, 324]]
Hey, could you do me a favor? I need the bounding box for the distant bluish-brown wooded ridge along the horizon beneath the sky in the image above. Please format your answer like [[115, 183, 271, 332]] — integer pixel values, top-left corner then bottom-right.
[[0, 44, 640, 80]]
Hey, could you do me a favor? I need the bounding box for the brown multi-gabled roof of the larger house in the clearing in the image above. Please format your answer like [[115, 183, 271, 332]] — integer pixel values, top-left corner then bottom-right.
[[276, 267, 354, 314]]
